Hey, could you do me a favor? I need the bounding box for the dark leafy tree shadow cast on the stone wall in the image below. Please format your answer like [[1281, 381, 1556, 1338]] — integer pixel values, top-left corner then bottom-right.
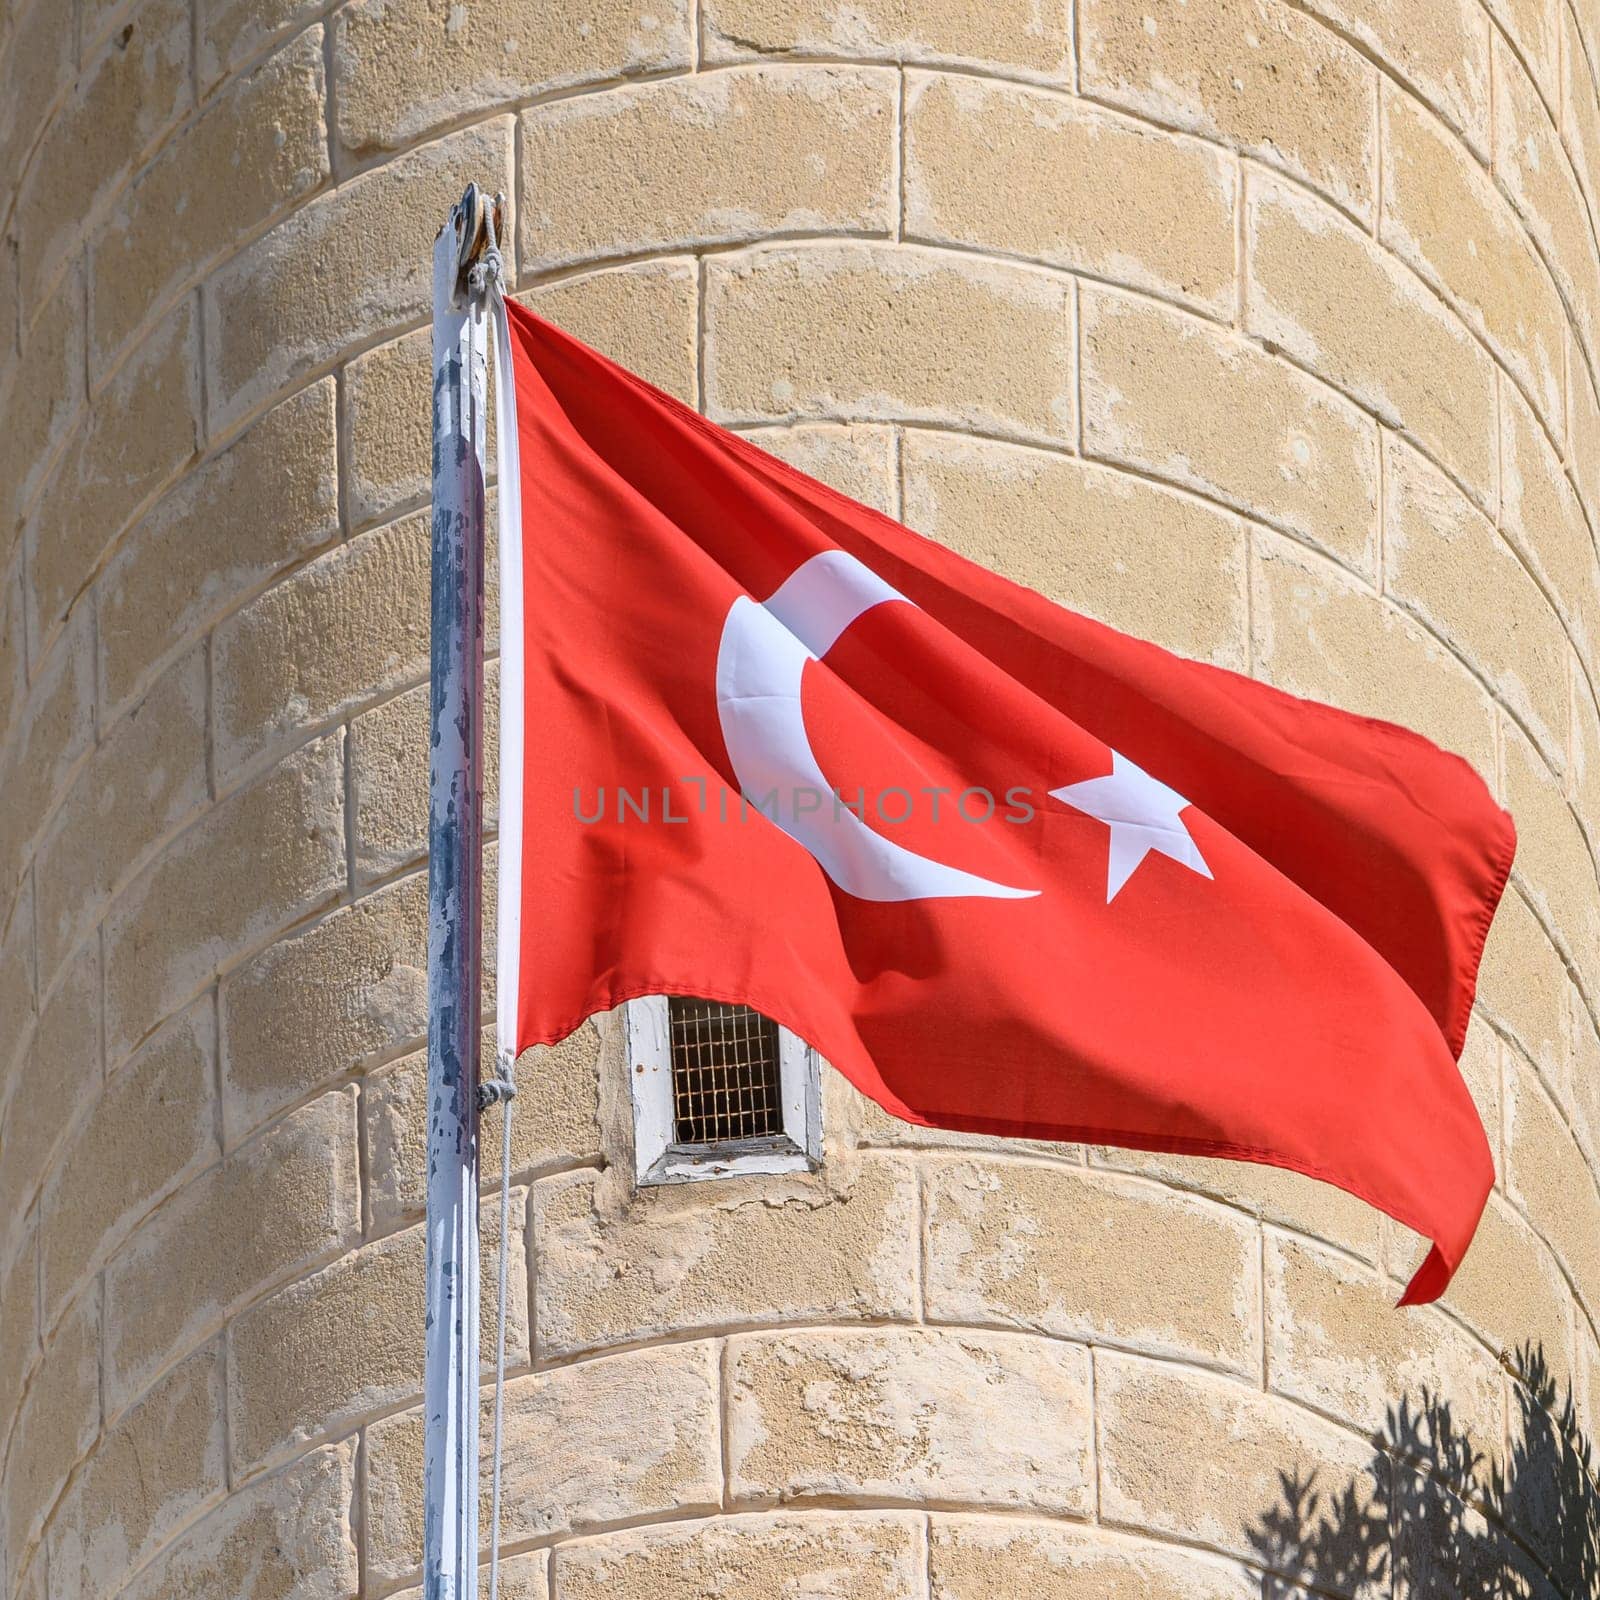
[[1250, 1346, 1600, 1600]]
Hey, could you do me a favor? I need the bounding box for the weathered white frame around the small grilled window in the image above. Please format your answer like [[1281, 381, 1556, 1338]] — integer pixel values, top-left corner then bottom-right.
[[622, 995, 822, 1184]]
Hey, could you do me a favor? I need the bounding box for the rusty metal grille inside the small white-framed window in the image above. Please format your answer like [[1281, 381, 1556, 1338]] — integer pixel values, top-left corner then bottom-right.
[[667, 997, 784, 1144]]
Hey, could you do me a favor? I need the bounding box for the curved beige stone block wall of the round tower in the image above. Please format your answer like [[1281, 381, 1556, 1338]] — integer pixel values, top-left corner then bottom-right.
[[0, 0, 1600, 1600]]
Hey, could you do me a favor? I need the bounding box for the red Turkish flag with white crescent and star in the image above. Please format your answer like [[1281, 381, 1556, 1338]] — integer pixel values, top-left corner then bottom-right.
[[499, 294, 1515, 1302]]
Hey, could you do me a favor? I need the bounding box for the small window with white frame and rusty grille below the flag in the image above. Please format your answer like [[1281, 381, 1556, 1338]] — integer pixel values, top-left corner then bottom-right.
[[626, 995, 822, 1184]]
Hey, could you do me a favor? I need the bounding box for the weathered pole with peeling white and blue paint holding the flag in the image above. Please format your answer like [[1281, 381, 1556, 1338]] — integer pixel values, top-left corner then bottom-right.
[[422, 184, 490, 1600]]
